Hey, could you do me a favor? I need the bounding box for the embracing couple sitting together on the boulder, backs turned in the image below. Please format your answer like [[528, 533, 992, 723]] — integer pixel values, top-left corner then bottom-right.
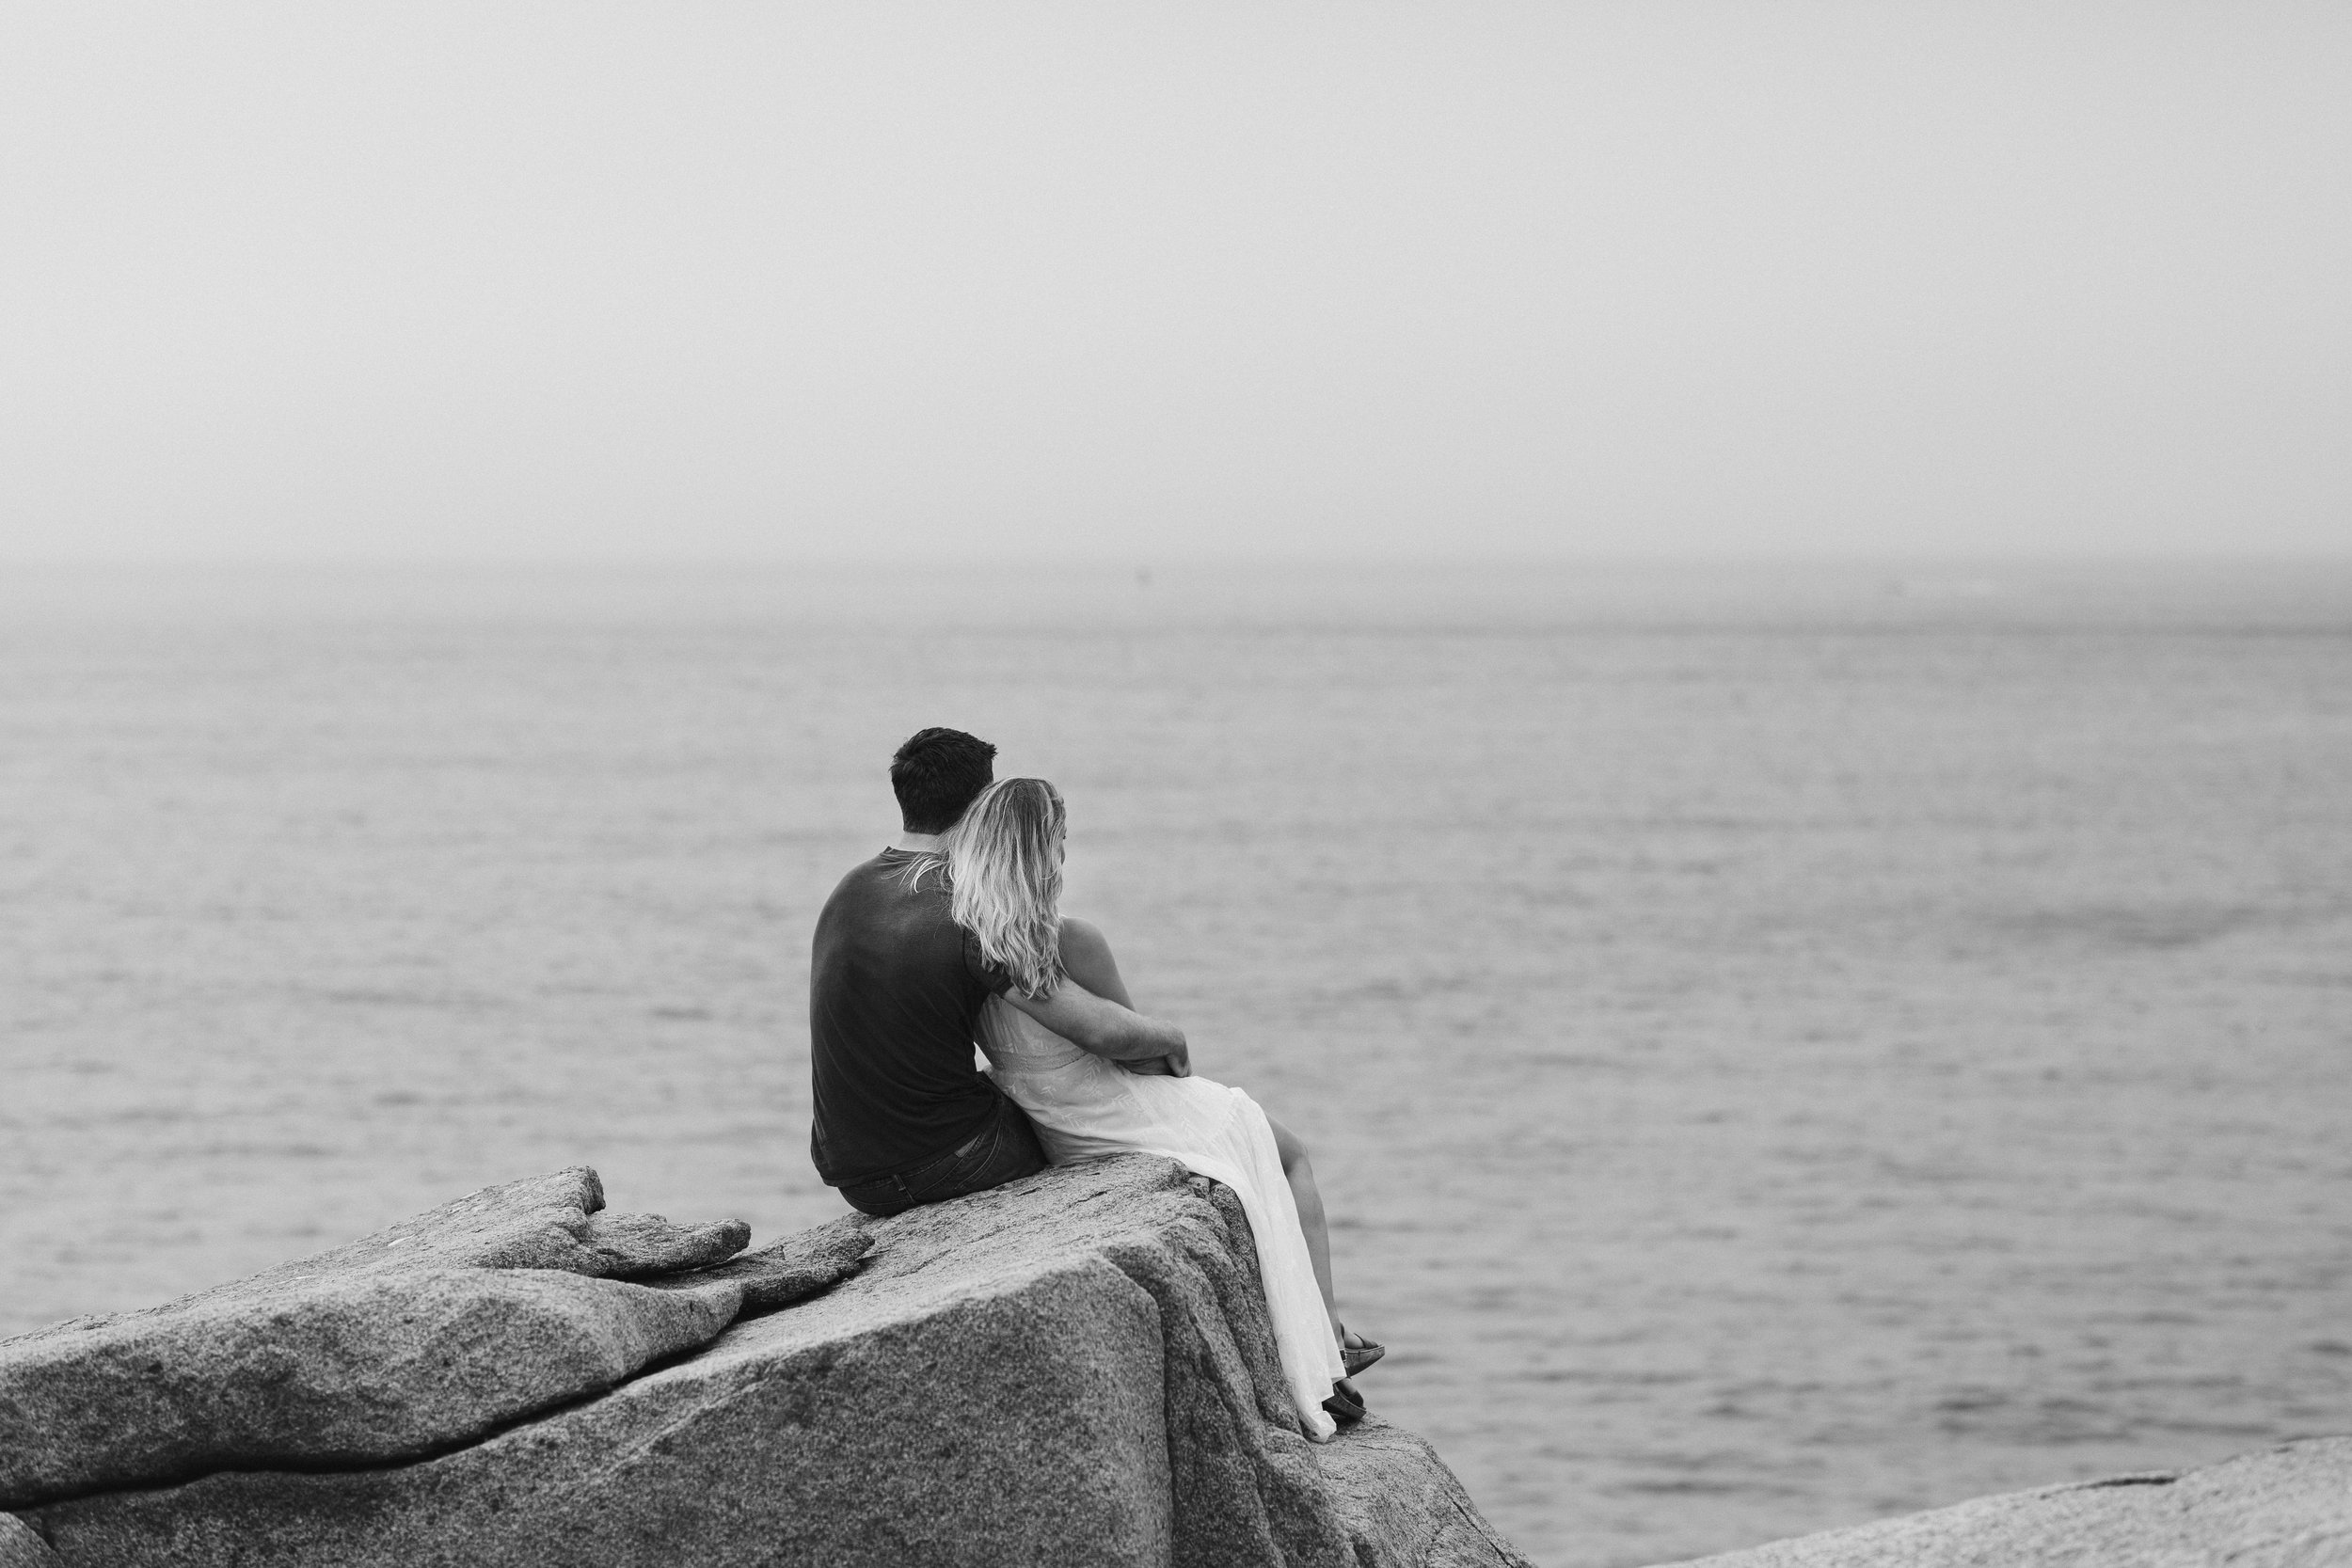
[[809, 729, 1381, 1439]]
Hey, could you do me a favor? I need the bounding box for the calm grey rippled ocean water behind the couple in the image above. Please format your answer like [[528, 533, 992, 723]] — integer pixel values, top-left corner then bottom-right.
[[0, 562, 2352, 1568]]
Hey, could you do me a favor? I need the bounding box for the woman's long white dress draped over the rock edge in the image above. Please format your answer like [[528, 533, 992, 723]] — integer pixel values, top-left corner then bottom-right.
[[981, 997, 1348, 1441]]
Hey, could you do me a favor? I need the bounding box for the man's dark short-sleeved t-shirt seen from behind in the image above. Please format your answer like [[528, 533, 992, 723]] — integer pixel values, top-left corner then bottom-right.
[[809, 848, 1009, 1187]]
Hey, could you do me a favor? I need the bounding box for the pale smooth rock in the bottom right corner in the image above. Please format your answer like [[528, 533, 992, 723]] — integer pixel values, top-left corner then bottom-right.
[[1665, 1436, 2352, 1568]]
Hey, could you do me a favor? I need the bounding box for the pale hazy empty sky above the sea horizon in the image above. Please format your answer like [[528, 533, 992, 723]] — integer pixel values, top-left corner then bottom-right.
[[0, 0, 2352, 560]]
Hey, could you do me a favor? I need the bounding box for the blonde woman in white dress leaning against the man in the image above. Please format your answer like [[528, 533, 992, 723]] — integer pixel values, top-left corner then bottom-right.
[[936, 778, 1381, 1441]]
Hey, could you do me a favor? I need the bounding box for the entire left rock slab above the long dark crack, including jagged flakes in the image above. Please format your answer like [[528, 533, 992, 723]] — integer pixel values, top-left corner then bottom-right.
[[0, 1168, 864, 1513]]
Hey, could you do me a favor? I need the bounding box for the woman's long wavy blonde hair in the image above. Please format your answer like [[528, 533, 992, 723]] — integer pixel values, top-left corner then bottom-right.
[[948, 778, 1068, 997]]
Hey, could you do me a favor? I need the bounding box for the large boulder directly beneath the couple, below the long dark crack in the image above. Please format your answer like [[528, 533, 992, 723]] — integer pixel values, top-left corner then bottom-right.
[[28, 1157, 1524, 1568]]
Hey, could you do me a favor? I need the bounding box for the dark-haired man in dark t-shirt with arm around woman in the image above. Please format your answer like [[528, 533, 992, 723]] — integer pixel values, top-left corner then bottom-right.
[[809, 729, 1185, 1215]]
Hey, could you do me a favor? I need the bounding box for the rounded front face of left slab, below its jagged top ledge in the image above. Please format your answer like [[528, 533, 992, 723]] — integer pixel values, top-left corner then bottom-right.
[[0, 1270, 743, 1510]]
